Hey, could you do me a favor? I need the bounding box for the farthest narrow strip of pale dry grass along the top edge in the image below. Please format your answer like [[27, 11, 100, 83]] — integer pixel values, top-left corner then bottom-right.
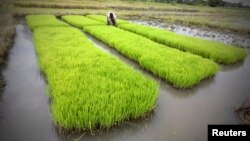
[[14, 0, 197, 12]]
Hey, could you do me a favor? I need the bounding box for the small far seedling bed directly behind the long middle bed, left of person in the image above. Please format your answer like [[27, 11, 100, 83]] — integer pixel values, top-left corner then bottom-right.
[[62, 15, 104, 28]]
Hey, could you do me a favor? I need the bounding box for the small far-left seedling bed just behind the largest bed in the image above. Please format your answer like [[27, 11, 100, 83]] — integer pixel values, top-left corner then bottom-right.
[[25, 15, 68, 30]]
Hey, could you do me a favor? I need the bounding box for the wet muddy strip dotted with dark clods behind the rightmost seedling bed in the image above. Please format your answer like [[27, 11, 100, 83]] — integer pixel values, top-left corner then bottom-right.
[[131, 21, 250, 52]]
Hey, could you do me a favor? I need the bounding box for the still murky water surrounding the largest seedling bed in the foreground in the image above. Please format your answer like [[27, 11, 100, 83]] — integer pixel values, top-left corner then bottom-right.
[[0, 24, 250, 141]]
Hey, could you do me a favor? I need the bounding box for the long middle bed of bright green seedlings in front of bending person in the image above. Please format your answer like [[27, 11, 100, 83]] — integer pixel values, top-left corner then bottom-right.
[[83, 26, 219, 88]]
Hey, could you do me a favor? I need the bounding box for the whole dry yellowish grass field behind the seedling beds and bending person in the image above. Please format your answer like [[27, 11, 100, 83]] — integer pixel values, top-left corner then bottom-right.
[[8, 0, 250, 34]]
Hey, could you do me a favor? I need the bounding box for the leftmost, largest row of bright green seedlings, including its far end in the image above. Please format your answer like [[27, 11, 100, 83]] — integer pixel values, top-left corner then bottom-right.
[[26, 15, 159, 131]]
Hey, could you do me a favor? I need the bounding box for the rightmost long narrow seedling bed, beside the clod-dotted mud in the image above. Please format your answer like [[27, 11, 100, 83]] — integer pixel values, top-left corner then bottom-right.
[[118, 24, 247, 64]]
